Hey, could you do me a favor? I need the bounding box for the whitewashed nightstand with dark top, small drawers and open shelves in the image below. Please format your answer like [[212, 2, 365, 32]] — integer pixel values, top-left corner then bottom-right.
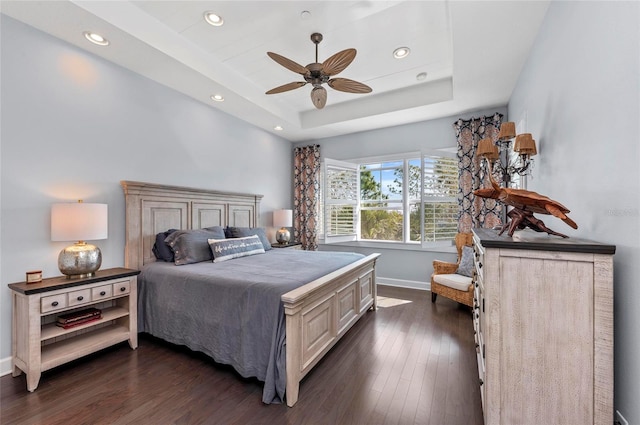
[[9, 268, 140, 391]]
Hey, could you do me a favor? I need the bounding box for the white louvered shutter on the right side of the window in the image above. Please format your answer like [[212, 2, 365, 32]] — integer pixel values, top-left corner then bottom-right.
[[422, 154, 458, 245]]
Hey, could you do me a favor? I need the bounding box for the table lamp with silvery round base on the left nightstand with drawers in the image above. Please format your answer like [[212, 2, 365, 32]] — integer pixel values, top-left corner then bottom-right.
[[51, 200, 108, 278]]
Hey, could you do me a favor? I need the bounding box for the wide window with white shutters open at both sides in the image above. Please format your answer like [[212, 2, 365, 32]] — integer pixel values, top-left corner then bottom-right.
[[321, 153, 458, 246]]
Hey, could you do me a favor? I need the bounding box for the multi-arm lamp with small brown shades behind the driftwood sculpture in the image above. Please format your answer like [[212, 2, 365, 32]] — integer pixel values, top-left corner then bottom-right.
[[476, 122, 538, 187]]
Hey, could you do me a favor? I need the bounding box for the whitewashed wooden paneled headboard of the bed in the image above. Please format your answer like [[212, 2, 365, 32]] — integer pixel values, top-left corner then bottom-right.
[[120, 181, 262, 270]]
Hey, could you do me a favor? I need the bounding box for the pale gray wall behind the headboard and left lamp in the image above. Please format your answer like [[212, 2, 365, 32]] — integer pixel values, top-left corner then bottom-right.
[[0, 15, 292, 362]]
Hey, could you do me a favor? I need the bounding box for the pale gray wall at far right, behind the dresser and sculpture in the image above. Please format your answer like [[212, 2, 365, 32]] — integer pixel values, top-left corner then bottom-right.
[[509, 2, 640, 424]]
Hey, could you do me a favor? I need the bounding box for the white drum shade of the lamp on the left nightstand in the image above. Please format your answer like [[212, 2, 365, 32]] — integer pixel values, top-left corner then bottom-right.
[[51, 202, 108, 241]]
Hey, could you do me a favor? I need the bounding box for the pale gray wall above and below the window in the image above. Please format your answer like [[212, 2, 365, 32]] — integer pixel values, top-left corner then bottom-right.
[[296, 106, 507, 289]]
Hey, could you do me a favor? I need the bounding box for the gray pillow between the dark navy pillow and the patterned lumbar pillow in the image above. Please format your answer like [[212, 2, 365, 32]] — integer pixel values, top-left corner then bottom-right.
[[164, 226, 224, 266]]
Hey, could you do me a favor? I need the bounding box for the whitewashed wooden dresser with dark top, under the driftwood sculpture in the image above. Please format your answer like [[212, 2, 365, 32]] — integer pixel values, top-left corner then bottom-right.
[[473, 229, 615, 425]]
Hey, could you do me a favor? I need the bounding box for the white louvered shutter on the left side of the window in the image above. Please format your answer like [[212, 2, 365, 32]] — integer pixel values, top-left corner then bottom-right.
[[323, 159, 360, 243]]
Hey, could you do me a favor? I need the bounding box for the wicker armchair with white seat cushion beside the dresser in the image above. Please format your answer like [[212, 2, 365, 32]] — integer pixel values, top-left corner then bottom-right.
[[431, 233, 473, 307]]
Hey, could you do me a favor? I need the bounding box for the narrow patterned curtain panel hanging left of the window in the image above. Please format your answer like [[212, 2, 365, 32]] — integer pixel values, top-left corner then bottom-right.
[[293, 145, 320, 251]]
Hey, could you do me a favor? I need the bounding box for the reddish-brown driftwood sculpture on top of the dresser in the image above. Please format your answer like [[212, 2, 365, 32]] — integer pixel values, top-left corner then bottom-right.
[[473, 161, 578, 238]]
